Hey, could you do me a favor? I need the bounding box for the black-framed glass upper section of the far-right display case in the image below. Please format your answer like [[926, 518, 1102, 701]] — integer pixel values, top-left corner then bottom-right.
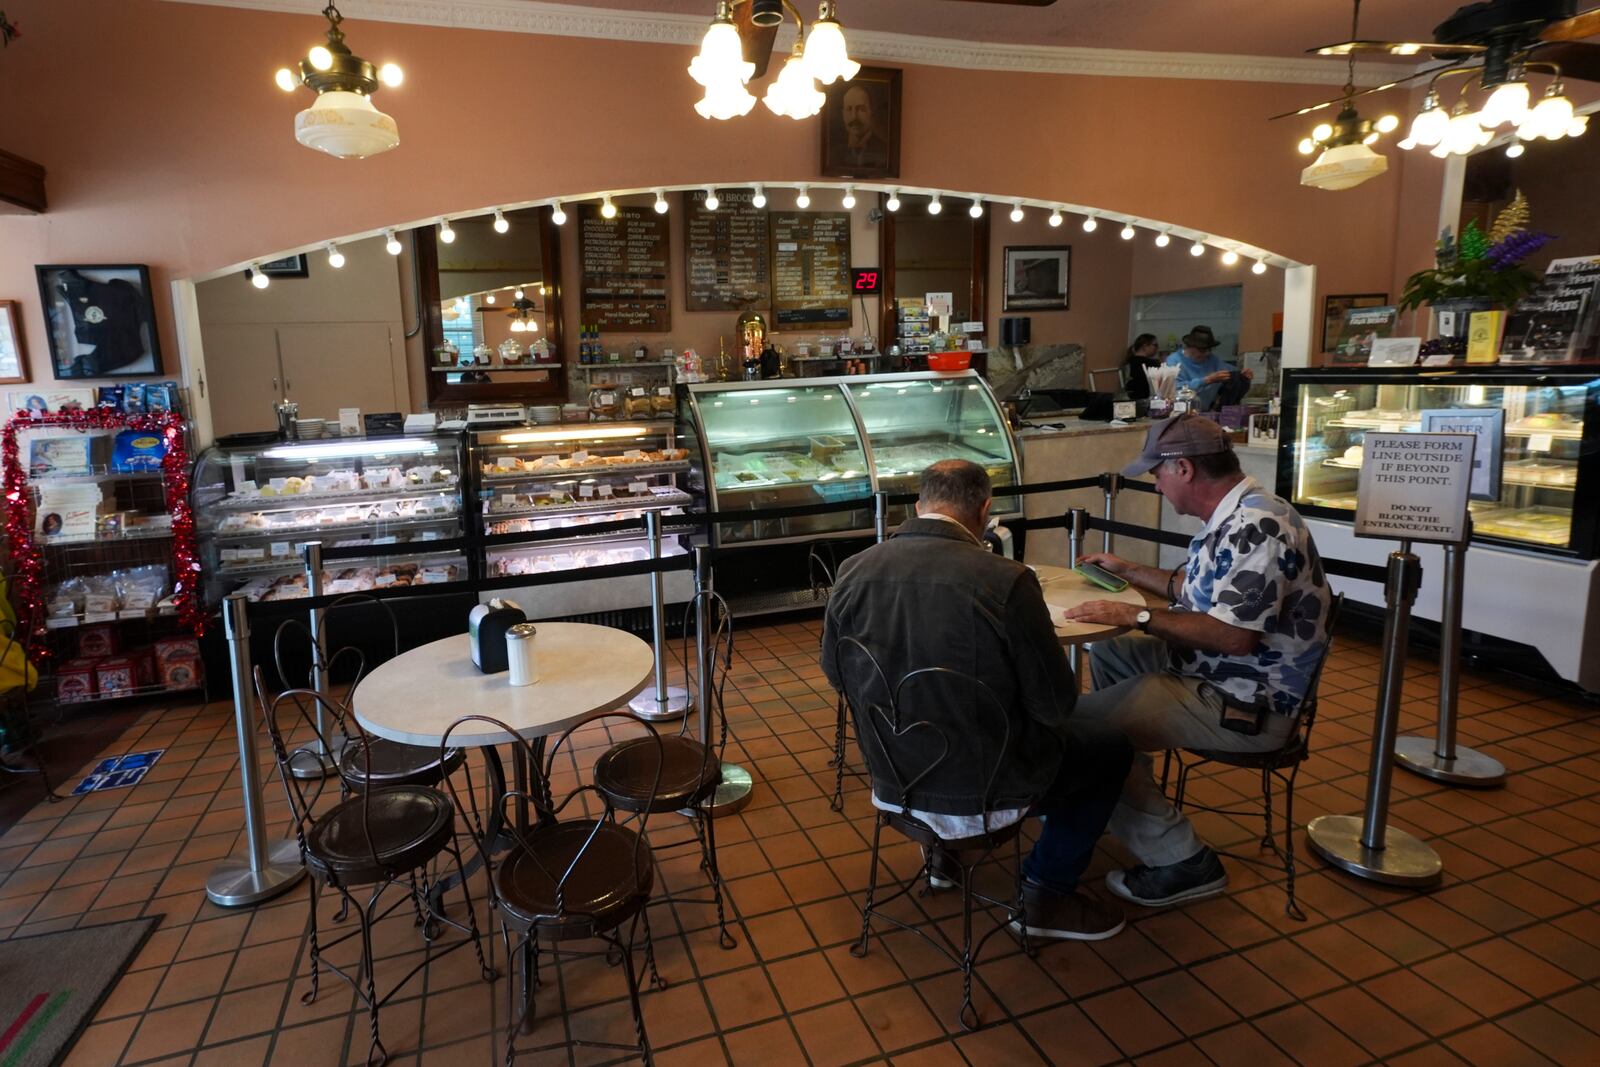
[[1278, 368, 1600, 560]]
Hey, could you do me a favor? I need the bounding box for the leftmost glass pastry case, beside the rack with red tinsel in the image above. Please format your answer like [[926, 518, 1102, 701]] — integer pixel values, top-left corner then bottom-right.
[[192, 434, 467, 605]]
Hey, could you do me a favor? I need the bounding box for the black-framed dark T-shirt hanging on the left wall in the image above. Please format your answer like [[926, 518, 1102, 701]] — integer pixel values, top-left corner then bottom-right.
[[34, 264, 162, 381]]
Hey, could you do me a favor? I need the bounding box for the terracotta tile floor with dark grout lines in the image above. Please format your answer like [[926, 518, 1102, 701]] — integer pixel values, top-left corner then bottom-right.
[[0, 621, 1600, 1067]]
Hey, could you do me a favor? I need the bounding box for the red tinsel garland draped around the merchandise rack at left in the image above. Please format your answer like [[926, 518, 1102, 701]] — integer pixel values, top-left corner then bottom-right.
[[0, 408, 206, 662]]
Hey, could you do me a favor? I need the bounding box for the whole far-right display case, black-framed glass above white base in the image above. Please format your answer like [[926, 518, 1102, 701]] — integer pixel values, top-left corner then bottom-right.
[[1277, 366, 1600, 691]]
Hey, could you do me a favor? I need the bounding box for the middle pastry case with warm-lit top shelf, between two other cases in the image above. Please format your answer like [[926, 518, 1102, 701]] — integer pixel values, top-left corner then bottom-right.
[[469, 422, 693, 577]]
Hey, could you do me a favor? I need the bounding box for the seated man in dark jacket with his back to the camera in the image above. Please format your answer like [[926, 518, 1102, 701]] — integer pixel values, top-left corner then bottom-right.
[[822, 459, 1131, 941]]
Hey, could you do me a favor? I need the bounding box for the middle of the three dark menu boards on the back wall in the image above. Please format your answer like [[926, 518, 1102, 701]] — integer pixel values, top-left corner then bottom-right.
[[683, 189, 773, 312]]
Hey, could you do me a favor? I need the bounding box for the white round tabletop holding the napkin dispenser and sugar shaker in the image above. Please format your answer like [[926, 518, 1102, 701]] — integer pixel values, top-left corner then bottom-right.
[[354, 622, 656, 749]]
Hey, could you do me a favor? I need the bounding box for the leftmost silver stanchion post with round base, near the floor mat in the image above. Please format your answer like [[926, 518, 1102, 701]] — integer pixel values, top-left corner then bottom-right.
[[205, 593, 306, 907]]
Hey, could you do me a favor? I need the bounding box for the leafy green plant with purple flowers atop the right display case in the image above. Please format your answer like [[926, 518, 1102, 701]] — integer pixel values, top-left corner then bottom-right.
[[1400, 192, 1550, 336]]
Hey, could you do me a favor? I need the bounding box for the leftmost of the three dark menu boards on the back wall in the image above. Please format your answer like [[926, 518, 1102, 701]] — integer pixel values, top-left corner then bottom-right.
[[578, 203, 672, 333]]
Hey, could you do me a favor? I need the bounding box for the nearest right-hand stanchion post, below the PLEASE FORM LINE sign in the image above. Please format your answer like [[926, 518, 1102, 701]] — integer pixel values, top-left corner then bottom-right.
[[1306, 541, 1443, 886]]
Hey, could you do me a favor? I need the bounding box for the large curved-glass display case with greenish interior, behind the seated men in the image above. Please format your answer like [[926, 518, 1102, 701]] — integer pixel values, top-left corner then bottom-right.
[[678, 371, 1021, 545]]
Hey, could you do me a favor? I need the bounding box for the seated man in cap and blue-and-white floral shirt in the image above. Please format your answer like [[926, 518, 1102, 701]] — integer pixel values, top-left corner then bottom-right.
[[1067, 414, 1331, 907]]
